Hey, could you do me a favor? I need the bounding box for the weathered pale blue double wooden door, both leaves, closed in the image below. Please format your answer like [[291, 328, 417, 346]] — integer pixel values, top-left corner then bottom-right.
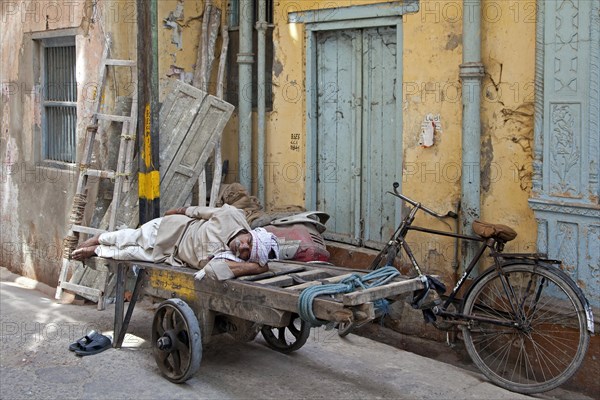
[[316, 27, 402, 246]]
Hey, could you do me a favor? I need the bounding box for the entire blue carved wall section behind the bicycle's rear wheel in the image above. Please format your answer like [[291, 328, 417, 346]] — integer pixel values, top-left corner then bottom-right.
[[529, 0, 600, 307]]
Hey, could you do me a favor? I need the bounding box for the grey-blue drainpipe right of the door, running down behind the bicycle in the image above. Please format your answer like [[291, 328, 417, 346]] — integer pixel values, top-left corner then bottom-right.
[[459, 0, 484, 267]]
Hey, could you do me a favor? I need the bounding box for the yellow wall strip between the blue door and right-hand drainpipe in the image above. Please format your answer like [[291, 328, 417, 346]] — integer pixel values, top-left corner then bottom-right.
[[402, 2, 462, 277]]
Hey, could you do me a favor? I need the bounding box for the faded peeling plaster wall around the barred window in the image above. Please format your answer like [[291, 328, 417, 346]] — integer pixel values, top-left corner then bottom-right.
[[0, 0, 135, 286]]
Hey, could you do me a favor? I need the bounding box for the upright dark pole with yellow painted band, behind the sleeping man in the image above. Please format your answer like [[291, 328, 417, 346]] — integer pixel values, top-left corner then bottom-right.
[[137, 0, 160, 224]]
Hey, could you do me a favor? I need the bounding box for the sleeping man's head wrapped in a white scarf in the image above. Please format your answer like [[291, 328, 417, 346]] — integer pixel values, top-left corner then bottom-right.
[[229, 228, 279, 266]]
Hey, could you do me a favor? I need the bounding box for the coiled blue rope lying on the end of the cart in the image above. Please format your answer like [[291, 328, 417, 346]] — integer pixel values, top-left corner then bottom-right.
[[298, 266, 400, 326]]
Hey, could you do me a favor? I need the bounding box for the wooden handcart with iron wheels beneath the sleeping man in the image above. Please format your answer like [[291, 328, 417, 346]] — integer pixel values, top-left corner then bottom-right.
[[95, 258, 423, 383]]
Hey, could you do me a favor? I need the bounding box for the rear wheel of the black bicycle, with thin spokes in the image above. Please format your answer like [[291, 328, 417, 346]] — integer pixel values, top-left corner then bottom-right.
[[463, 264, 590, 393]]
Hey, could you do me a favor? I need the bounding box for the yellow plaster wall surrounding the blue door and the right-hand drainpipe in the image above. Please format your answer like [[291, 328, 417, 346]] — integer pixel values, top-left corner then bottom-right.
[[217, 0, 536, 274]]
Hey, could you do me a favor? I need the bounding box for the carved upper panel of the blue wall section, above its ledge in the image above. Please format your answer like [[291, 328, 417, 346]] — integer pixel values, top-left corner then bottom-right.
[[532, 0, 600, 200]]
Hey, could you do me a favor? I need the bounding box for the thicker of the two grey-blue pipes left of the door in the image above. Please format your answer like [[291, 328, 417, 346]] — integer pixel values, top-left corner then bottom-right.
[[237, 0, 254, 191]]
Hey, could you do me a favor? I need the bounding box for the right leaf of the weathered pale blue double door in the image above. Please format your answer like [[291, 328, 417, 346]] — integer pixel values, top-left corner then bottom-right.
[[360, 28, 402, 247]]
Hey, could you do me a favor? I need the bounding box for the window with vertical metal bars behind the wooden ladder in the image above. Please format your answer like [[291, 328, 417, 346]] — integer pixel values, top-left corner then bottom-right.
[[41, 37, 77, 163]]
